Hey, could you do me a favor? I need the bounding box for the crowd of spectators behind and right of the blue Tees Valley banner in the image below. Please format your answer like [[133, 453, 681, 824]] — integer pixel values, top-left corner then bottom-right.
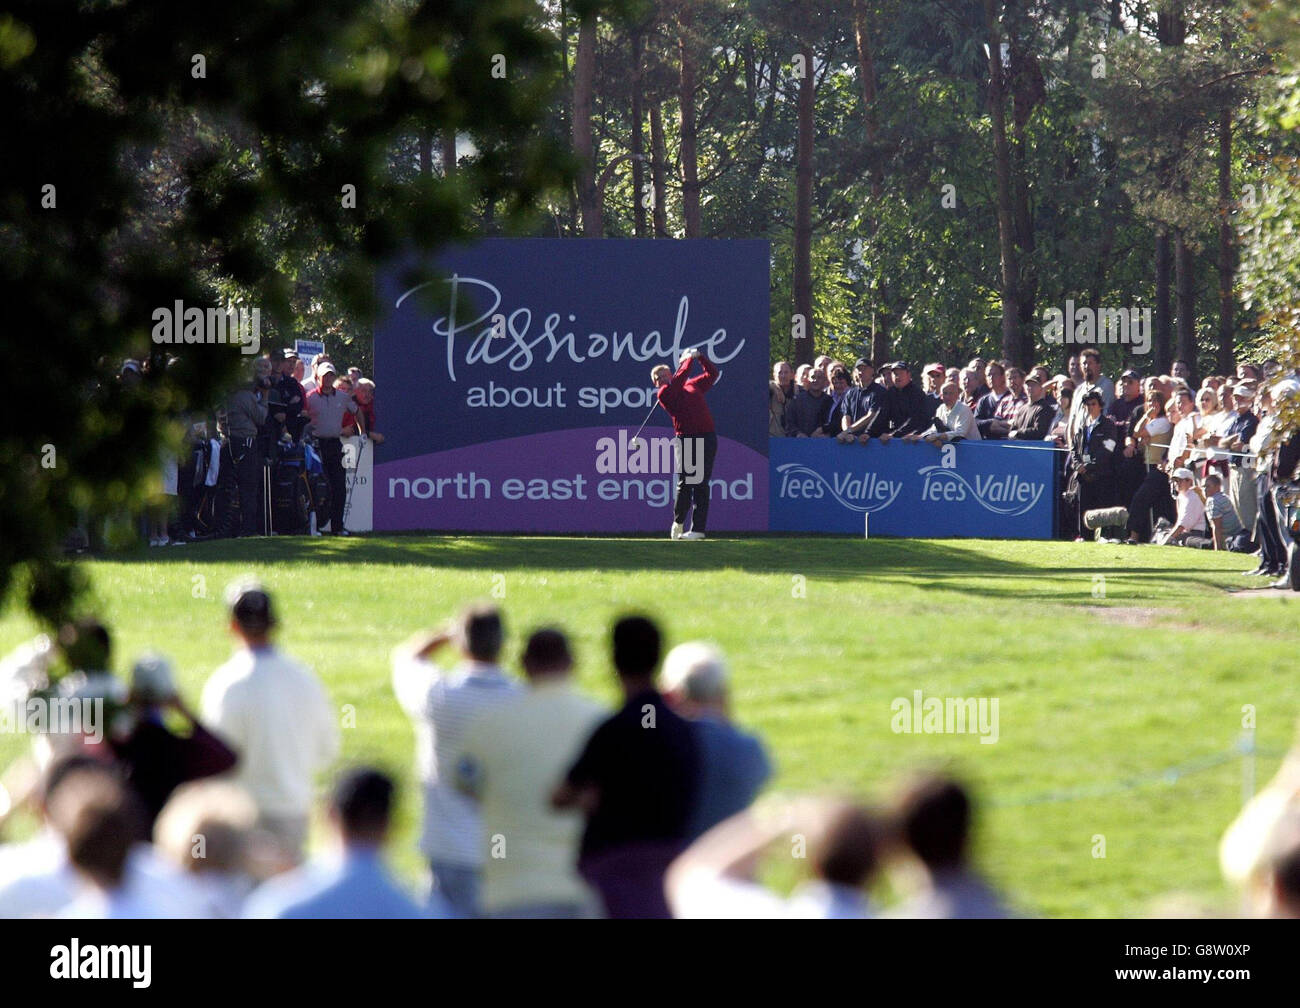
[[768, 347, 1300, 584]]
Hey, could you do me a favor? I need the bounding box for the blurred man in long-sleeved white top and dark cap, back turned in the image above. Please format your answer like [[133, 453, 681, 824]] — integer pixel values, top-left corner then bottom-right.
[[202, 583, 339, 861]]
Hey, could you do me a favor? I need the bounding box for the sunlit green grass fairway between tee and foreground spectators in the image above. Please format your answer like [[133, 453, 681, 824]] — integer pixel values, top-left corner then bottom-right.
[[0, 536, 1300, 917]]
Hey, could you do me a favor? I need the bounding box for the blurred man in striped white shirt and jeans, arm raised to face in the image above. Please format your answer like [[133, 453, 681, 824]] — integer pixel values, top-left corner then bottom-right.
[[393, 606, 519, 917]]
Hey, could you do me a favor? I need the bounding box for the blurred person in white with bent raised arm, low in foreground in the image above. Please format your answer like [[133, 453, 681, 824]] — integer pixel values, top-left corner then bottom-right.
[[666, 800, 881, 920]]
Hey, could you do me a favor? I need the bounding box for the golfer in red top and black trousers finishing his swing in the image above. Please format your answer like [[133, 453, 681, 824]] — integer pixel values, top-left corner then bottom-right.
[[650, 350, 718, 538]]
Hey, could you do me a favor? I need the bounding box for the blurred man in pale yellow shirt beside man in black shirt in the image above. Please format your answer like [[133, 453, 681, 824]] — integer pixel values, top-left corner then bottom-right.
[[456, 628, 608, 917]]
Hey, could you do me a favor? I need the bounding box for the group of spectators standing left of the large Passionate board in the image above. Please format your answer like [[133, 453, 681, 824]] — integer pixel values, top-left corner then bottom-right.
[[99, 349, 384, 546]]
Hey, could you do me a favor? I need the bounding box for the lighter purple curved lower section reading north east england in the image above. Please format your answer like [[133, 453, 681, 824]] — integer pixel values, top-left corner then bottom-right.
[[374, 427, 768, 532]]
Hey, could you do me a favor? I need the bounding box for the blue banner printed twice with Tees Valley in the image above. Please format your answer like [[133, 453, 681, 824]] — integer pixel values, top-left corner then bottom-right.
[[768, 438, 1057, 538]]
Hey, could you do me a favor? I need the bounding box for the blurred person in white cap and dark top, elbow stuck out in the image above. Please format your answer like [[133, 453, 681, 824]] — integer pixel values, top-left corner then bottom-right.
[[109, 654, 237, 831]]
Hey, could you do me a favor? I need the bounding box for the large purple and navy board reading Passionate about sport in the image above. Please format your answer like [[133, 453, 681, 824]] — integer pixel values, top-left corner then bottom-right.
[[373, 238, 770, 532]]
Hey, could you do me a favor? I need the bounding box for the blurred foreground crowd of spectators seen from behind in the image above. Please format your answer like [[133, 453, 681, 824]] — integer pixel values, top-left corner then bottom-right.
[[0, 581, 1300, 918]]
